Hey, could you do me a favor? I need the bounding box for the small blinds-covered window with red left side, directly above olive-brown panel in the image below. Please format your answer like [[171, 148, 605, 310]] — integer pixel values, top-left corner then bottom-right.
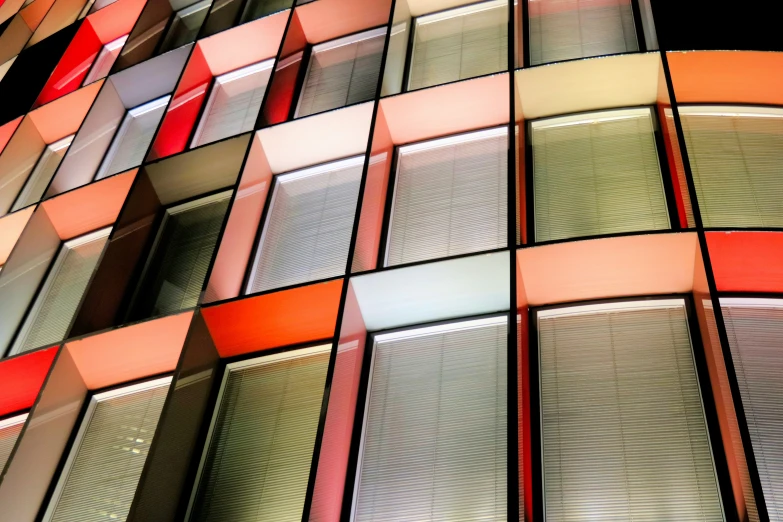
[[191, 60, 274, 147]]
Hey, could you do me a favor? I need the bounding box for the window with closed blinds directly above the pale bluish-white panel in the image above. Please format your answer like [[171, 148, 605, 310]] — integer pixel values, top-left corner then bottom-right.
[[386, 127, 508, 266]]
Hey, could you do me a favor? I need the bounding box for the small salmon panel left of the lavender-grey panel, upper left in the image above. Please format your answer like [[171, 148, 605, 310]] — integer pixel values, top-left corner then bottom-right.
[[30, 80, 103, 139]]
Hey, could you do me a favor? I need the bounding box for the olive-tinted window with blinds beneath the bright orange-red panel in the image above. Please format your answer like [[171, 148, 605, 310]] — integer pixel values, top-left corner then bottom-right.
[[187, 345, 331, 522]]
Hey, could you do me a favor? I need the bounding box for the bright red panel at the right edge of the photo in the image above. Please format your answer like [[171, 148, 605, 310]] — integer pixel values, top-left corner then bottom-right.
[[707, 232, 783, 293]]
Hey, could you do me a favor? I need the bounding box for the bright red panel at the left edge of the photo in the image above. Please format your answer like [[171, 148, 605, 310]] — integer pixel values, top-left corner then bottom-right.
[[0, 346, 58, 418]]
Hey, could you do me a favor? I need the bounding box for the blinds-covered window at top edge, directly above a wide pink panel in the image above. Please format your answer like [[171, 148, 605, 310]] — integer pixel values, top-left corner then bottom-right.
[[408, 0, 508, 90]]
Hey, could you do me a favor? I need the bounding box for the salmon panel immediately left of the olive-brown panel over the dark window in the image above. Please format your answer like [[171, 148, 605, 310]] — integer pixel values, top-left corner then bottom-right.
[[41, 169, 138, 241]]
